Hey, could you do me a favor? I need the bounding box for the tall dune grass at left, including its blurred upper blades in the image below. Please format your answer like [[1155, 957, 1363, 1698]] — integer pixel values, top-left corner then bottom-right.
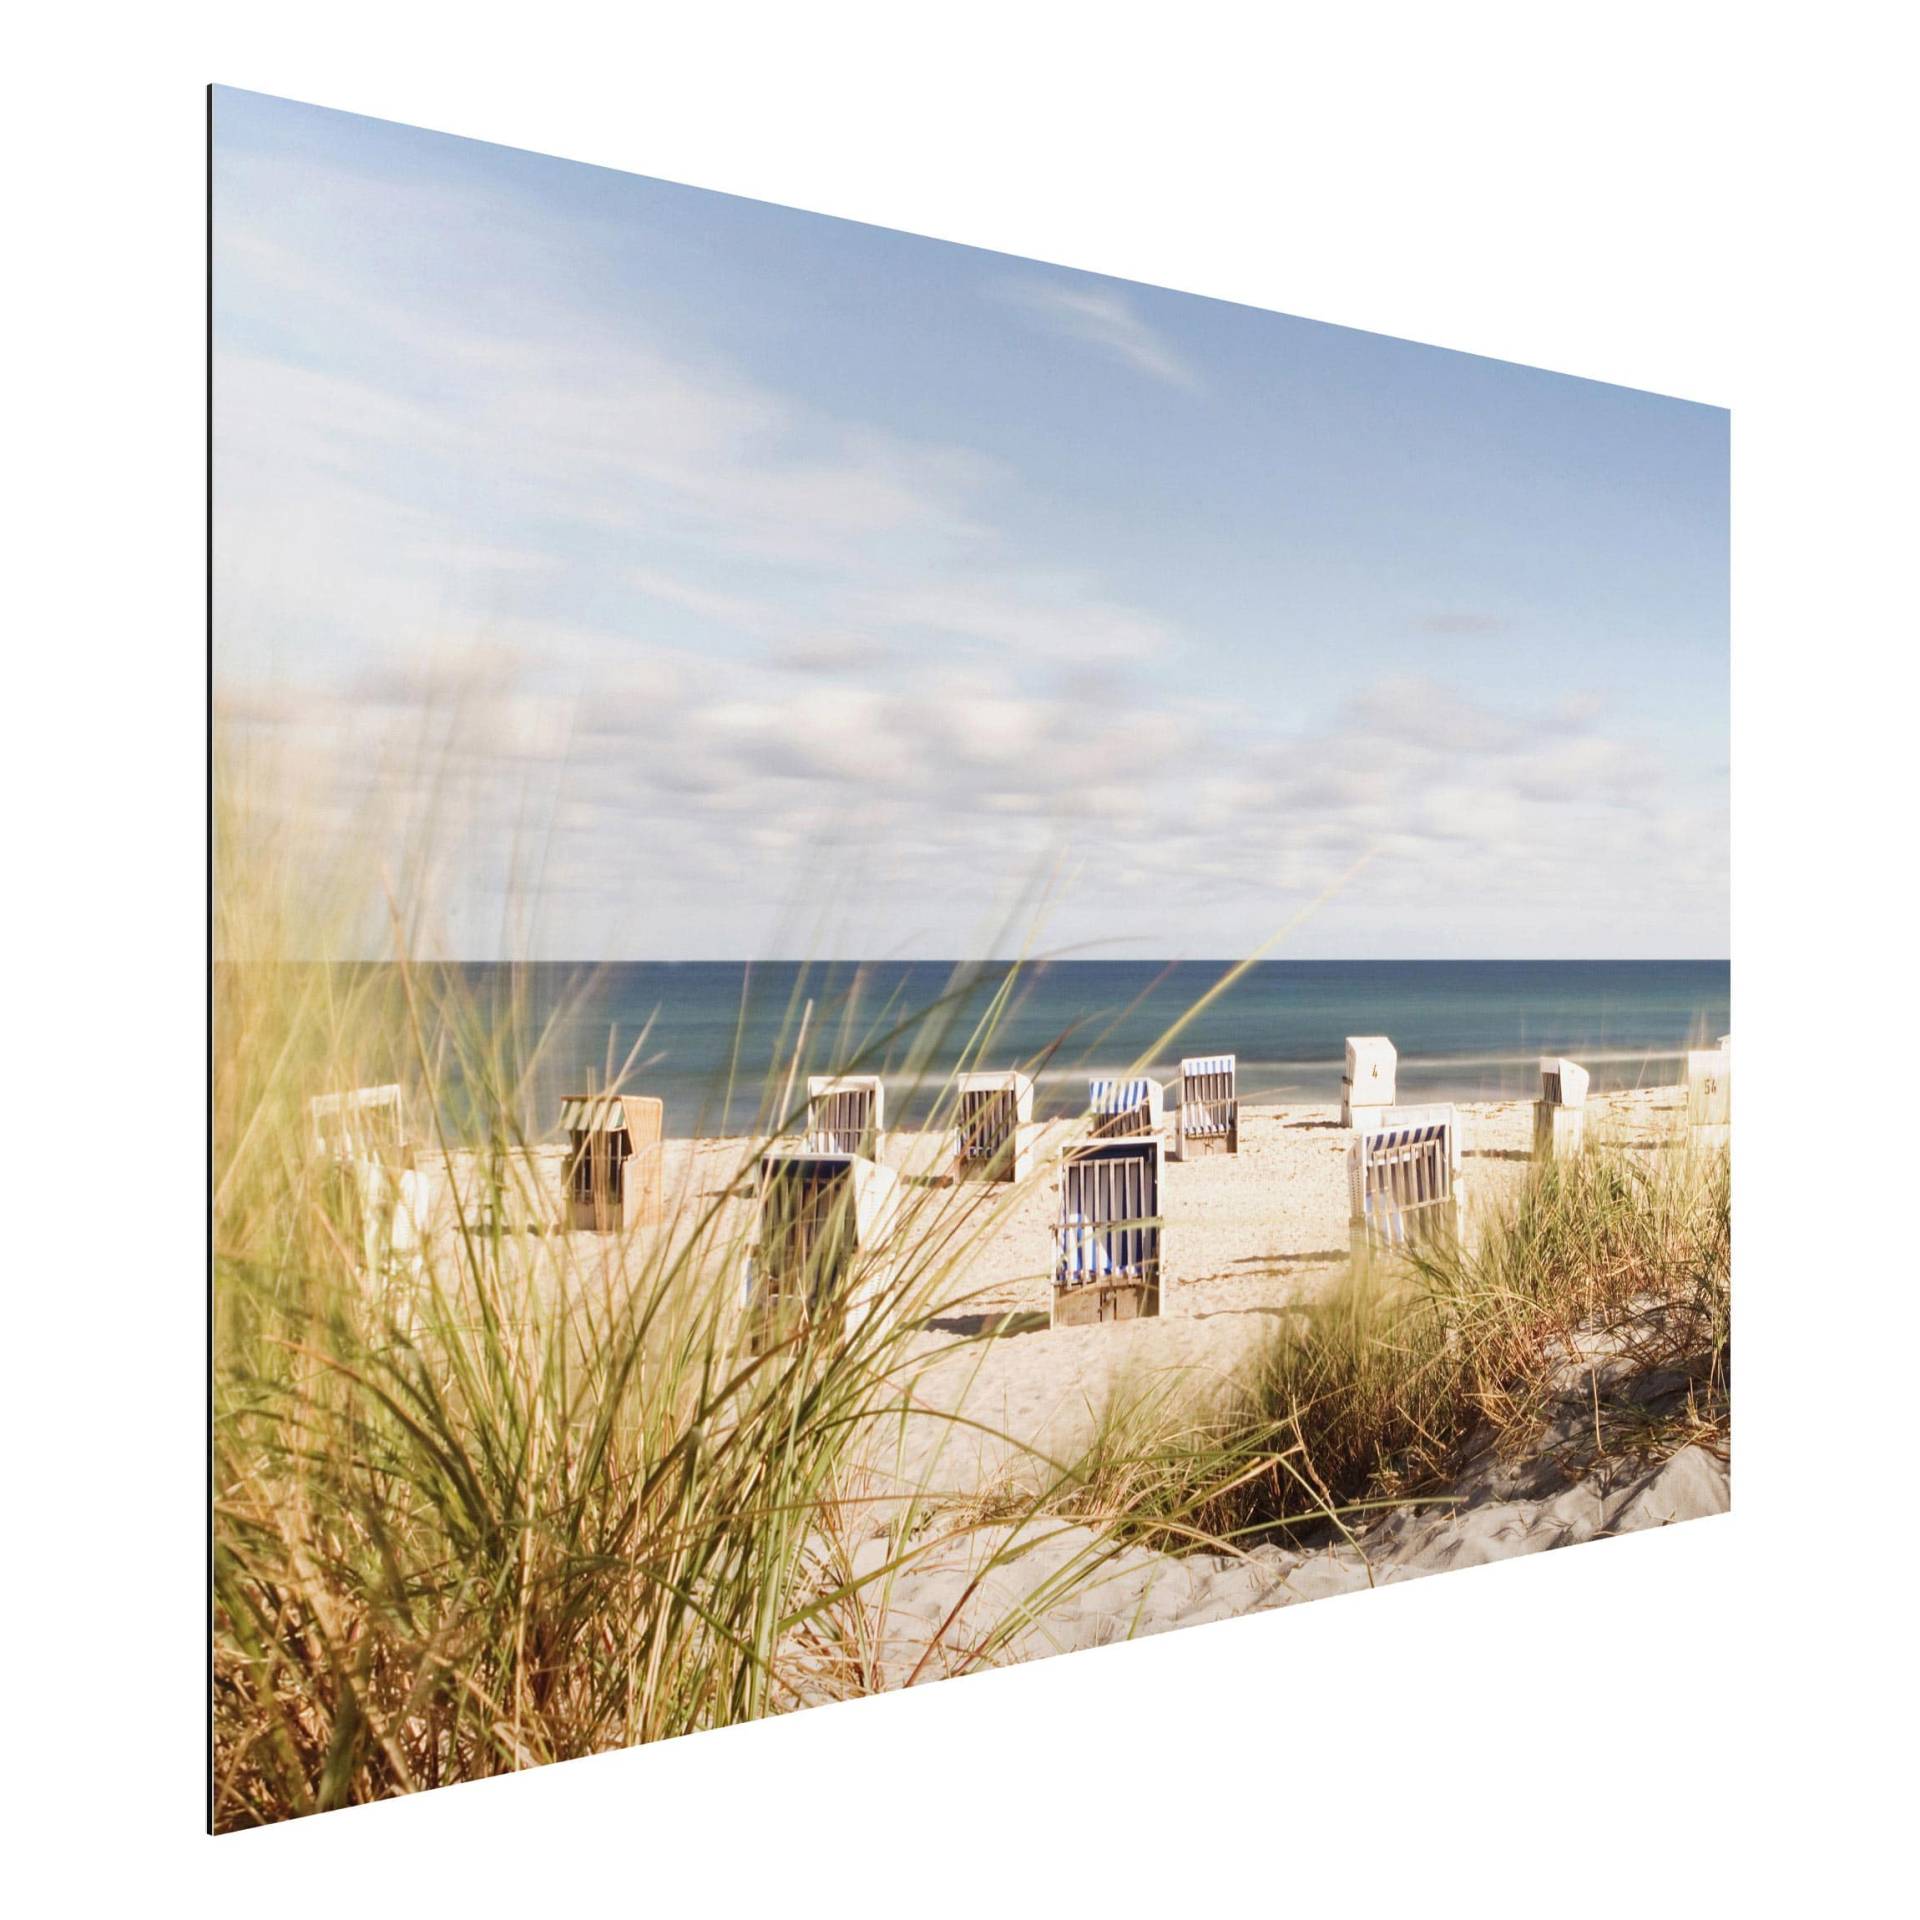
[[211, 752, 1182, 1828]]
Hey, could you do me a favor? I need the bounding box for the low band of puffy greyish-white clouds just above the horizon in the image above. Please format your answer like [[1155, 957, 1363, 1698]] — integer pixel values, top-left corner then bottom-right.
[[230, 649, 1726, 956]]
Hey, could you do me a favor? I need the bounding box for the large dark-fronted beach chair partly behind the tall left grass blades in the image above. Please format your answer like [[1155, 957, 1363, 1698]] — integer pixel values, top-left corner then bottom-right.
[[745, 1146, 900, 1350]]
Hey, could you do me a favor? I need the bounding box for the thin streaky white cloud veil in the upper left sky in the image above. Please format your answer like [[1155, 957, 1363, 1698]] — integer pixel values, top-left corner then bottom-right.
[[215, 161, 1169, 691]]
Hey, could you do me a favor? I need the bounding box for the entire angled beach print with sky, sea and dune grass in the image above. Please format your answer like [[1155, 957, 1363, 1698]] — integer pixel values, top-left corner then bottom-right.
[[209, 88, 1732, 1832]]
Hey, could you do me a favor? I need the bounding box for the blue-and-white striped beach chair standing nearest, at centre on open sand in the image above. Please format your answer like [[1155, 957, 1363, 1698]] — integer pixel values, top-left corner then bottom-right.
[[1052, 1135, 1162, 1327]]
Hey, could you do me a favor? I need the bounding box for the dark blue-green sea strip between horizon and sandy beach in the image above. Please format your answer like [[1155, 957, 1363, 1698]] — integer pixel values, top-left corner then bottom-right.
[[428, 960, 1732, 1135]]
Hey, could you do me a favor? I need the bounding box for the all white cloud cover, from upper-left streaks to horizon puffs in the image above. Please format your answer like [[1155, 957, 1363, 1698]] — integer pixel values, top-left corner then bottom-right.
[[215, 145, 1726, 958]]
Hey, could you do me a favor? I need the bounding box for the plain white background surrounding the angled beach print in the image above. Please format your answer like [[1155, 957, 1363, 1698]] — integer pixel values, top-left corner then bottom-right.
[[0, 0, 1916, 1914]]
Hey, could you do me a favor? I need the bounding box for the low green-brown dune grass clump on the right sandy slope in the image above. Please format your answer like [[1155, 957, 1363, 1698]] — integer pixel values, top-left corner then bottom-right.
[[1073, 1146, 1732, 1551]]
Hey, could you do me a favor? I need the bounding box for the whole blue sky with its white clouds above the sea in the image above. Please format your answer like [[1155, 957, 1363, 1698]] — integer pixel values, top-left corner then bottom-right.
[[213, 88, 1728, 958]]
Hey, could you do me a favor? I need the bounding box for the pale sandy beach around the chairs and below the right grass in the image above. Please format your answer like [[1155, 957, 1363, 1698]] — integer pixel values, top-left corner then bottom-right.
[[408, 1087, 1728, 1684]]
